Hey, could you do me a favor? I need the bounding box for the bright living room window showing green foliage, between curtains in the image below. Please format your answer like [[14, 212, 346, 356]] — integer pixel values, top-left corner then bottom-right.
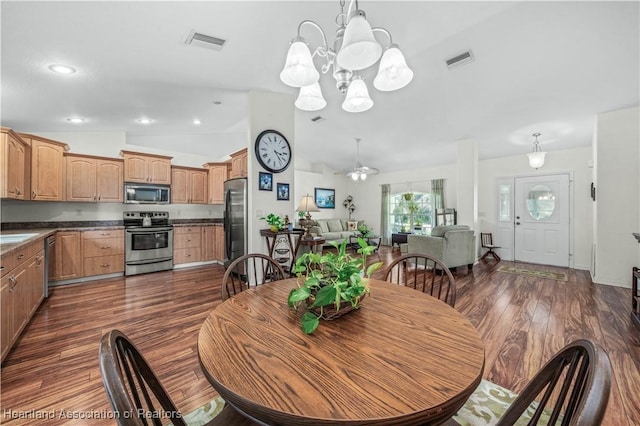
[[389, 192, 433, 235]]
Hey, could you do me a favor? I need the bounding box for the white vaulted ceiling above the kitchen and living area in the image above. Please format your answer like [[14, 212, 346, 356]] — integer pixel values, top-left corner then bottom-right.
[[0, 0, 640, 172]]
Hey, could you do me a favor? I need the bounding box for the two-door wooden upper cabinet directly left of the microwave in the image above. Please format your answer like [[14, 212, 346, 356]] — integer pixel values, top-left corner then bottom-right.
[[65, 153, 124, 203]]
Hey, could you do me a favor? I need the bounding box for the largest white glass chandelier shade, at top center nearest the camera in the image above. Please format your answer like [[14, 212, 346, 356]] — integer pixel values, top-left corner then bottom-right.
[[336, 10, 382, 70]]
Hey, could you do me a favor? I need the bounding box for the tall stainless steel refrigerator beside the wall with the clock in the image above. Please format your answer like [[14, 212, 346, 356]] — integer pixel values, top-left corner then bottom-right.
[[224, 178, 248, 268]]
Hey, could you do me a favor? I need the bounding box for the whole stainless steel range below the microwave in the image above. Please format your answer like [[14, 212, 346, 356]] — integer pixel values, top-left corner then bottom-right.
[[124, 212, 173, 275]]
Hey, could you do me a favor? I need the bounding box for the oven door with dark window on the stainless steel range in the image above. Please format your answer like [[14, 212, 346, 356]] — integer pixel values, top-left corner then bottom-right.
[[125, 227, 173, 262]]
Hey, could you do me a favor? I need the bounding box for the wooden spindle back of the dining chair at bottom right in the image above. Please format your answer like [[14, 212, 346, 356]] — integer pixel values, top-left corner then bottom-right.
[[498, 339, 611, 426]]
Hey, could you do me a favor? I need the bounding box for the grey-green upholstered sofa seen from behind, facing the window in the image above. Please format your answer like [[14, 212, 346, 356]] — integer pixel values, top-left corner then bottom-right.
[[400, 225, 476, 269]]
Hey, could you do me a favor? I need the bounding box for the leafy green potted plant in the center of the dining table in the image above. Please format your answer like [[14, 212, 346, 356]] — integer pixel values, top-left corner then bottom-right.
[[288, 238, 382, 334]]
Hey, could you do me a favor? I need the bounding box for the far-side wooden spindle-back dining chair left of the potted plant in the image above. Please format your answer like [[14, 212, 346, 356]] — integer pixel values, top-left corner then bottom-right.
[[222, 253, 288, 300]]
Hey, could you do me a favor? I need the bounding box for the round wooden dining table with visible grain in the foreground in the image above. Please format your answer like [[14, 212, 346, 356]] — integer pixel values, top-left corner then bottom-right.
[[198, 278, 484, 426]]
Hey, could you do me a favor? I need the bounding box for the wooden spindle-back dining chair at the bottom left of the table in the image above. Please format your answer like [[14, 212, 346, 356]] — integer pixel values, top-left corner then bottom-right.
[[99, 330, 264, 426]]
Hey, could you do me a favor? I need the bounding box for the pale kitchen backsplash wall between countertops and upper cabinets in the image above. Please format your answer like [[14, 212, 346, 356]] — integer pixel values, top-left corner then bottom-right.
[[0, 200, 224, 223]]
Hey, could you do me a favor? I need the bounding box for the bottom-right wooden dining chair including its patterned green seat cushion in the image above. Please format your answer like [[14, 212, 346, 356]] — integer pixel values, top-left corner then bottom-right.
[[446, 339, 611, 426]]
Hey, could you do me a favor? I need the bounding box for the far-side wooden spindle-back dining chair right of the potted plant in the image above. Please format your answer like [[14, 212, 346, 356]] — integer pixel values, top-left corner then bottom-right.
[[382, 253, 456, 307]]
